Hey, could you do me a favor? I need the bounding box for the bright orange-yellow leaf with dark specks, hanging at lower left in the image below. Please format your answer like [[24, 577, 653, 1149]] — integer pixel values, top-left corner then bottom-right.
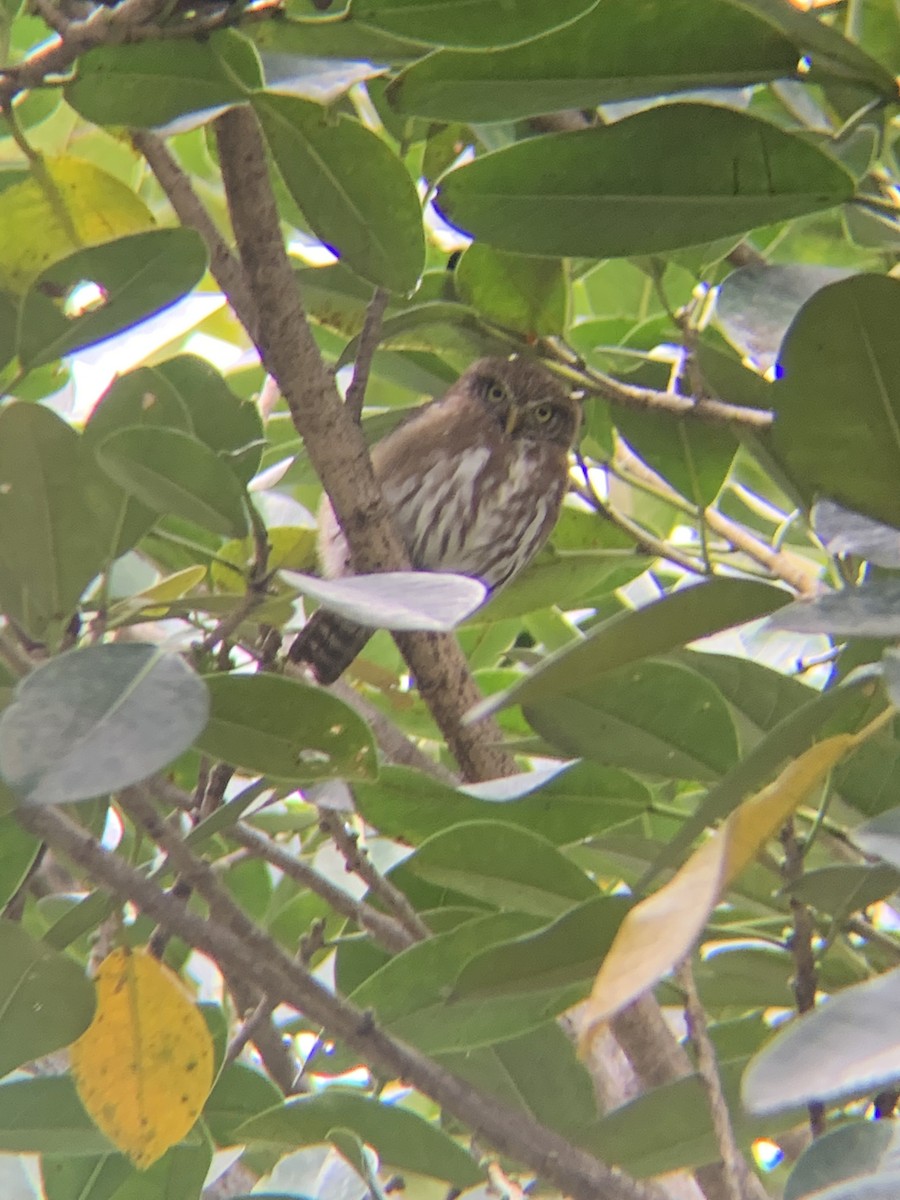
[[71, 949, 212, 1170]]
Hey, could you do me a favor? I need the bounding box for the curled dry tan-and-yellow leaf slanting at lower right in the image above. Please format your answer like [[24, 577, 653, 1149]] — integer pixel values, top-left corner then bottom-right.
[[581, 733, 859, 1052]]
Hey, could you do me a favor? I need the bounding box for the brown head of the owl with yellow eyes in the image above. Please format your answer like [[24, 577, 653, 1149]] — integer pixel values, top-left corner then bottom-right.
[[463, 358, 581, 450]]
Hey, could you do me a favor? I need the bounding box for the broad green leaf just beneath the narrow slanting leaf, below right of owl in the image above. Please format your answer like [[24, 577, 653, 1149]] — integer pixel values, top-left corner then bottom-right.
[[524, 660, 738, 779]]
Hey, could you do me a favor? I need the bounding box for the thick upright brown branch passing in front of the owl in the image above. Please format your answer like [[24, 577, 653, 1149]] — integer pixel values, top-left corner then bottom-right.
[[216, 109, 516, 779]]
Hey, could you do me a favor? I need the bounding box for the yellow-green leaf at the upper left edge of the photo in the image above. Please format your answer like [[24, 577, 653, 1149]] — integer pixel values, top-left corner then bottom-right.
[[0, 157, 155, 295]]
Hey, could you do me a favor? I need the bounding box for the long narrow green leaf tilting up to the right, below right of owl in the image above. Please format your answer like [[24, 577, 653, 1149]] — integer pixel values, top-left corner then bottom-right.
[[474, 578, 790, 715]]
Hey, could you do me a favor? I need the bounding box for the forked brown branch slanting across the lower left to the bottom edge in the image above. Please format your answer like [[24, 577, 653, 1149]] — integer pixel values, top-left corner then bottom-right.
[[18, 797, 662, 1200]]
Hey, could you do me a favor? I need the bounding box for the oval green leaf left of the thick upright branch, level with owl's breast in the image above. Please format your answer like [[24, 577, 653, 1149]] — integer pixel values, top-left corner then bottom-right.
[[96, 425, 248, 538]]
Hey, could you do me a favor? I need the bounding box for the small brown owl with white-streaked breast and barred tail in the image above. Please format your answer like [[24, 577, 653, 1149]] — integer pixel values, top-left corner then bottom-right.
[[290, 358, 581, 683]]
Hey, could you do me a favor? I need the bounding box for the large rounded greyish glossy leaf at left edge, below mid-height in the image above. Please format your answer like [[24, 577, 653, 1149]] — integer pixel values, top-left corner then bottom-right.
[[0, 643, 209, 804]]
